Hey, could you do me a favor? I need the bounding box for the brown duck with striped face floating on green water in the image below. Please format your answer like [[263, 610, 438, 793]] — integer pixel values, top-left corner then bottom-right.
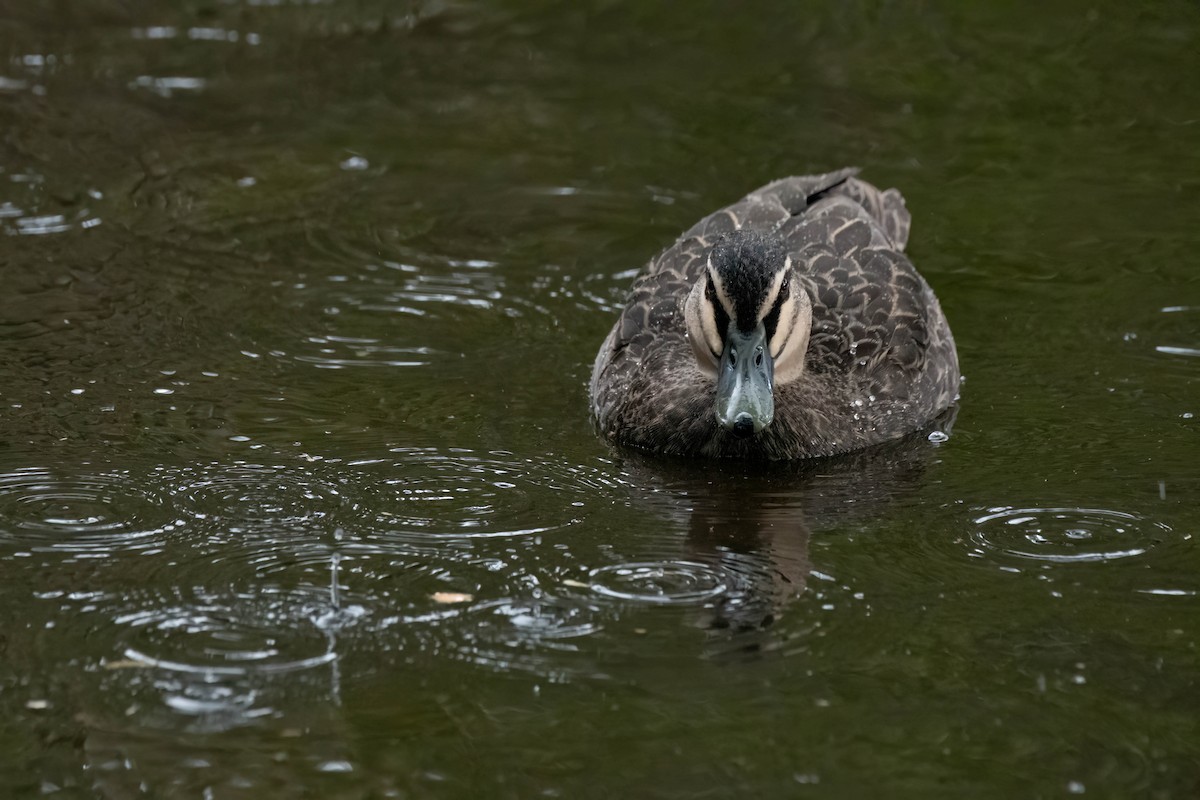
[[589, 167, 961, 461]]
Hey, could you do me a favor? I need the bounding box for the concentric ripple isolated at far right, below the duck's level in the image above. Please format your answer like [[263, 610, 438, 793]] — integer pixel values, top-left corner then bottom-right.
[[970, 506, 1171, 565]]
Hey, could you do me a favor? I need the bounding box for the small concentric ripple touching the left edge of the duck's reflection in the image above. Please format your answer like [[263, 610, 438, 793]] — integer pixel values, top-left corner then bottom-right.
[[588, 560, 730, 606]]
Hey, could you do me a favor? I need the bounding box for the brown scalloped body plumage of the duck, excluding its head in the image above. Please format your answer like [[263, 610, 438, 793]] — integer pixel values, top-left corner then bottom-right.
[[590, 169, 959, 459]]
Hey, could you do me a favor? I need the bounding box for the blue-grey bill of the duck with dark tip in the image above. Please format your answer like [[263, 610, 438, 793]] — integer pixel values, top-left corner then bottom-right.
[[716, 325, 775, 438]]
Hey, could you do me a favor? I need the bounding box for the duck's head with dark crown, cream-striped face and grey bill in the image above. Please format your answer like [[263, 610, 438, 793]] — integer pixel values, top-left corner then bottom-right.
[[684, 230, 812, 438]]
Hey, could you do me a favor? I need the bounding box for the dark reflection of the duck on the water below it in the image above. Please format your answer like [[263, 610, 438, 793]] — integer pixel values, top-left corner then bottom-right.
[[622, 413, 954, 632]]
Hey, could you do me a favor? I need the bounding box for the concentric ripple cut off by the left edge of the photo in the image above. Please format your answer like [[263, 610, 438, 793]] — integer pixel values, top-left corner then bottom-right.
[[0, 468, 185, 558]]
